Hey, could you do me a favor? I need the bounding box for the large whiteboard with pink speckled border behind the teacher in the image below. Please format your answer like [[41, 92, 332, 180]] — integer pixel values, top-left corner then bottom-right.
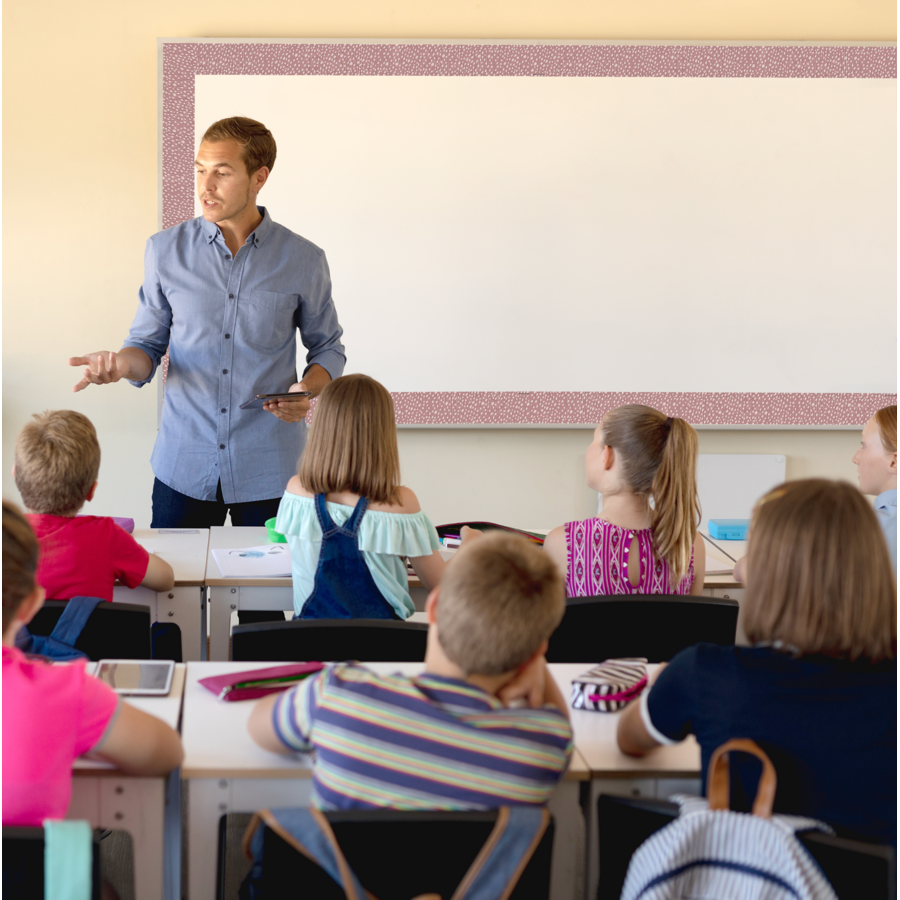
[[160, 39, 897, 426]]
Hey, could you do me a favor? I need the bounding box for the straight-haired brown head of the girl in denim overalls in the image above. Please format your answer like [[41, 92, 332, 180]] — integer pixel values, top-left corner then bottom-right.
[[298, 375, 400, 503]]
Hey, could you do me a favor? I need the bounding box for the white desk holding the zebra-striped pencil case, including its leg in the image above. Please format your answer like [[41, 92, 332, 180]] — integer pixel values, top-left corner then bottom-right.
[[550, 663, 701, 898]]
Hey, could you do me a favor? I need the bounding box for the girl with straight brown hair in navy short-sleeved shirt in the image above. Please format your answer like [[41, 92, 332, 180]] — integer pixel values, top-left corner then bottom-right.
[[618, 479, 897, 848]]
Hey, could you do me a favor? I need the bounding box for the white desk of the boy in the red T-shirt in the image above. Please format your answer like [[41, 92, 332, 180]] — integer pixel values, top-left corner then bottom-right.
[[113, 528, 209, 660]]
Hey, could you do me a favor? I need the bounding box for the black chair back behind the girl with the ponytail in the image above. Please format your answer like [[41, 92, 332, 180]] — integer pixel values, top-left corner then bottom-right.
[[547, 594, 738, 662]]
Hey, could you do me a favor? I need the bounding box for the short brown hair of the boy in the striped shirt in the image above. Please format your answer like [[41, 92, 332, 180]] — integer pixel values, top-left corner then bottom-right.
[[437, 531, 566, 675]]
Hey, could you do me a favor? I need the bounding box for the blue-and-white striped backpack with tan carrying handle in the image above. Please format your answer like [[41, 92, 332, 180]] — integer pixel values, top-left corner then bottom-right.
[[622, 739, 837, 900]]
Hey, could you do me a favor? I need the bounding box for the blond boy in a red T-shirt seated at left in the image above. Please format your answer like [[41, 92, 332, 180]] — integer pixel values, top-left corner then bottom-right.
[[13, 409, 175, 600]]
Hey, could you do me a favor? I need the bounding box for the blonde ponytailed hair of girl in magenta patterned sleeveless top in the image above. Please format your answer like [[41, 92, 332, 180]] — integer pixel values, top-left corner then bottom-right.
[[602, 403, 702, 582]]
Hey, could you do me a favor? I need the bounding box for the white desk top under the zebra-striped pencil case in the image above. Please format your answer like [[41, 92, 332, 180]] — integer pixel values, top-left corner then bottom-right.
[[550, 662, 700, 778]]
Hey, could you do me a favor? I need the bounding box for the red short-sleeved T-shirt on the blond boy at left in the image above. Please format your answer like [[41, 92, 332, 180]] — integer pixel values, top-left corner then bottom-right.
[[28, 513, 150, 600]]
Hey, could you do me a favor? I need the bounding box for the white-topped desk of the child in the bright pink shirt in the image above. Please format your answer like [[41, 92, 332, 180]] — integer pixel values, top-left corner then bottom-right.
[[66, 663, 187, 900]]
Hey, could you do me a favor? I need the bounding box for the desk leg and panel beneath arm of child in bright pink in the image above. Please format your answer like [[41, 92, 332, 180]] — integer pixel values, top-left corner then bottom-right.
[[67, 776, 165, 900]]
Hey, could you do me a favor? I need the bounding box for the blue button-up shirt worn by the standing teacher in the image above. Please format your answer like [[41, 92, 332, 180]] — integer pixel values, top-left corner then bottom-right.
[[124, 207, 346, 503]]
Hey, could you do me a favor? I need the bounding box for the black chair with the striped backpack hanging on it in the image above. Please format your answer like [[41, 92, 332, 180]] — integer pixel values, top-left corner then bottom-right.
[[597, 794, 896, 900]]
